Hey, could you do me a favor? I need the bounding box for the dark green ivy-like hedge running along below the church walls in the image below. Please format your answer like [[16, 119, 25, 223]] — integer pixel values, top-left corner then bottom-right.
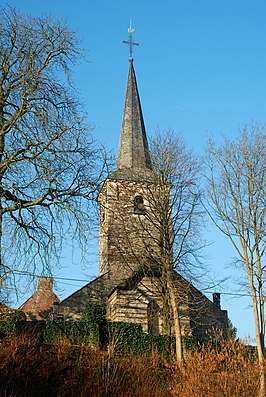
[[0, 304, 200, 358]]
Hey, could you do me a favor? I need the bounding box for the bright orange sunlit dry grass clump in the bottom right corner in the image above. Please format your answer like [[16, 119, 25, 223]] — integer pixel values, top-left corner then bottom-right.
[[172, 342, 259, 397]]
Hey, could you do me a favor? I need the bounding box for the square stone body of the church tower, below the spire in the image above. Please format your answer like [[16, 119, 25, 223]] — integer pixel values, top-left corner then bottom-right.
[[99, 179, 162, 285]]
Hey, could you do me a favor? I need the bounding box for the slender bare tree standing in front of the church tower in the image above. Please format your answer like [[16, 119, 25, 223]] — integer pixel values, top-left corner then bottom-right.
[[148, 130, 202, 365]]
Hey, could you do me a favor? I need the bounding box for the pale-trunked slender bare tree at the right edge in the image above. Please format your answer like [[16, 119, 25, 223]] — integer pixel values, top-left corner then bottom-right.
[[207, 126, 266, 397]]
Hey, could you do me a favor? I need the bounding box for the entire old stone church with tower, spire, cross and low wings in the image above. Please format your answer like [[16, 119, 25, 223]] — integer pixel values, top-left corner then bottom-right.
[[21, 30, 227, 337]]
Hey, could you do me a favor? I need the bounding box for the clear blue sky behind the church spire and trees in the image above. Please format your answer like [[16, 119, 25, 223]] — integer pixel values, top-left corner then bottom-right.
[[4, 0, 266, 337]]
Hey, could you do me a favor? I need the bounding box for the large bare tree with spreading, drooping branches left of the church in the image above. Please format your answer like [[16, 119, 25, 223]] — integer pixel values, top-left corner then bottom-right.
[[0, 7, 106, 296]]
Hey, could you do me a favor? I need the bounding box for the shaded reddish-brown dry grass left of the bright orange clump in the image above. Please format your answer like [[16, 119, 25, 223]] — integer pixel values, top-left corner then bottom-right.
[[0, 336, 172, 397]]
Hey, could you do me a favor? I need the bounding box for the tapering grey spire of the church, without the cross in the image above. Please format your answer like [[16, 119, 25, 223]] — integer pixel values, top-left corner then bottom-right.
[[117, 57, 152, 173]]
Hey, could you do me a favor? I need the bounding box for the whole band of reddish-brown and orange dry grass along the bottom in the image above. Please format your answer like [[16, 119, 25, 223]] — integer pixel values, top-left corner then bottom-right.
[[0, 335, 258, 397]]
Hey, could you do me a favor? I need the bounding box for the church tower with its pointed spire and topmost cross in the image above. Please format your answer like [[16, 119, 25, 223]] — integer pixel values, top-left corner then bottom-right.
[[99, 34, 154, 285]]
